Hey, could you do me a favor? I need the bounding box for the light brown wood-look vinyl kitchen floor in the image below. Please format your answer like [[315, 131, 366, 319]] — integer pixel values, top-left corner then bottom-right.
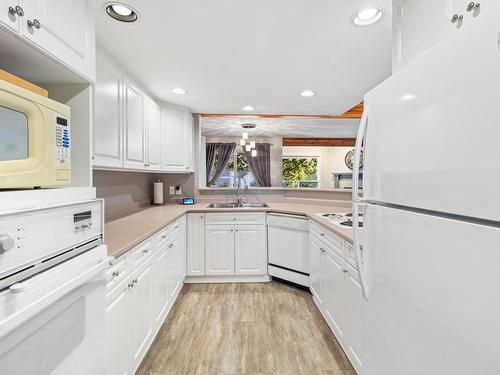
[[137, 282, 356, 375]]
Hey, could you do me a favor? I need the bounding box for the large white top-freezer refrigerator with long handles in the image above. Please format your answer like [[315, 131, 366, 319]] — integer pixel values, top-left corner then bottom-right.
[[353, 2, 500, 375]]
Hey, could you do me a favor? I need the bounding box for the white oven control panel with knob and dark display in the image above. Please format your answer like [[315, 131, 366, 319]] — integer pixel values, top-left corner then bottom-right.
[[0, 200, 103, 279]]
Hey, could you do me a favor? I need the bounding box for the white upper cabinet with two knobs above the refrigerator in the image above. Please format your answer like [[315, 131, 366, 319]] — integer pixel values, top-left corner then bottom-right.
[[393, 0, 477, 71]]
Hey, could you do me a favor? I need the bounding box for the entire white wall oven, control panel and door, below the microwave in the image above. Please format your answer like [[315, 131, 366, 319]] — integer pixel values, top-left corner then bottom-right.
[[0, 200, 108, 375]]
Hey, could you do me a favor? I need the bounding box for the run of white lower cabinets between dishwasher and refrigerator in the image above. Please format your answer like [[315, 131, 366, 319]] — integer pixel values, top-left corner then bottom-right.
[[309, 225, 363, 374]]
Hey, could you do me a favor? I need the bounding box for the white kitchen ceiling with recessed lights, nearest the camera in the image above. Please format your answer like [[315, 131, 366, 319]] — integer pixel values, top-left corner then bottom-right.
[[97, 0, 391, 114]]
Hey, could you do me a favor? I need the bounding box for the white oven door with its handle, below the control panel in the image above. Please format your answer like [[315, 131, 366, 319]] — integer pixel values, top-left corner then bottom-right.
[[0, 246, 108, 375]]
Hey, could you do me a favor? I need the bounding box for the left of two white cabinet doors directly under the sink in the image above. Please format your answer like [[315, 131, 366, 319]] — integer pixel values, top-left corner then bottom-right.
[[205, 225, 234, 276]]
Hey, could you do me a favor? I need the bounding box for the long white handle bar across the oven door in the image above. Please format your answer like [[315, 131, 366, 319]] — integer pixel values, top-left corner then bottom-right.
[[0, 259, 109, 339]]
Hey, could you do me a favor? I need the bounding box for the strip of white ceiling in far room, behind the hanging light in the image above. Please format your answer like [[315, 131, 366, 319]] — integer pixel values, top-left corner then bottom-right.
[[201, 117, 359, 138]]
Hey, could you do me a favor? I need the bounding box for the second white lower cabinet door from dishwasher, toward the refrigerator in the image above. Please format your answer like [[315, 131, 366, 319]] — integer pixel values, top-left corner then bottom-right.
[[321, 247, 348, 341]]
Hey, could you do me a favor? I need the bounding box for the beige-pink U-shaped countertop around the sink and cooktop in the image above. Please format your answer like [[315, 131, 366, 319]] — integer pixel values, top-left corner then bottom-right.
[[104, 201, 352, 257]]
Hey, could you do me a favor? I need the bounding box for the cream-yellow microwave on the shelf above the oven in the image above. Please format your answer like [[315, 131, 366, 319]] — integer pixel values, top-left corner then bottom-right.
[[0, 80, 72, 189]]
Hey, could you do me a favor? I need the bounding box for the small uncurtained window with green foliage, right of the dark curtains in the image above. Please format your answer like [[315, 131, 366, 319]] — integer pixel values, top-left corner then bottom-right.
[[283, 156, 319, 188]]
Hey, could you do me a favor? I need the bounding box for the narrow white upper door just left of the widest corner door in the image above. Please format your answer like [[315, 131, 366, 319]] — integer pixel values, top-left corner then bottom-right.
[[146, 98, 161, 169]]
